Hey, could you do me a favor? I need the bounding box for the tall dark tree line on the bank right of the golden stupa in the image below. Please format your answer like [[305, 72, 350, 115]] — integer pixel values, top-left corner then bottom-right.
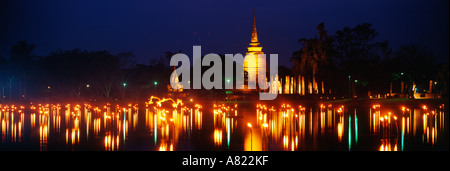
[[290, 23, 449, 97]]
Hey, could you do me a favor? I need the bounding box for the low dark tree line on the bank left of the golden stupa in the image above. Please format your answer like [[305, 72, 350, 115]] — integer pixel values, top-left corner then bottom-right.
[[0, 41, 171, 101]]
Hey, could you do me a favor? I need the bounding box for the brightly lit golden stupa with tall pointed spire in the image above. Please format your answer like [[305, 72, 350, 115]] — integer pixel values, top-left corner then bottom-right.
[[244, 11, 266, 90]]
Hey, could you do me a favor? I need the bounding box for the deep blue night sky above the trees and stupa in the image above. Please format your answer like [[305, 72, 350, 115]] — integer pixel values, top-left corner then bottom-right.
[[0, 0, 449, 66]]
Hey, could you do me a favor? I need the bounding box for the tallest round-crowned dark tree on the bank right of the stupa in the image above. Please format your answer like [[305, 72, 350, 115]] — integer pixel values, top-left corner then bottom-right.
[[333, 23, 391, 95]]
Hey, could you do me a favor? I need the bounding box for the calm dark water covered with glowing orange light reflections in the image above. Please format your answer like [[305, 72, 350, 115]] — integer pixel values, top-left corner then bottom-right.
[[0, 101, 449, 151]]
